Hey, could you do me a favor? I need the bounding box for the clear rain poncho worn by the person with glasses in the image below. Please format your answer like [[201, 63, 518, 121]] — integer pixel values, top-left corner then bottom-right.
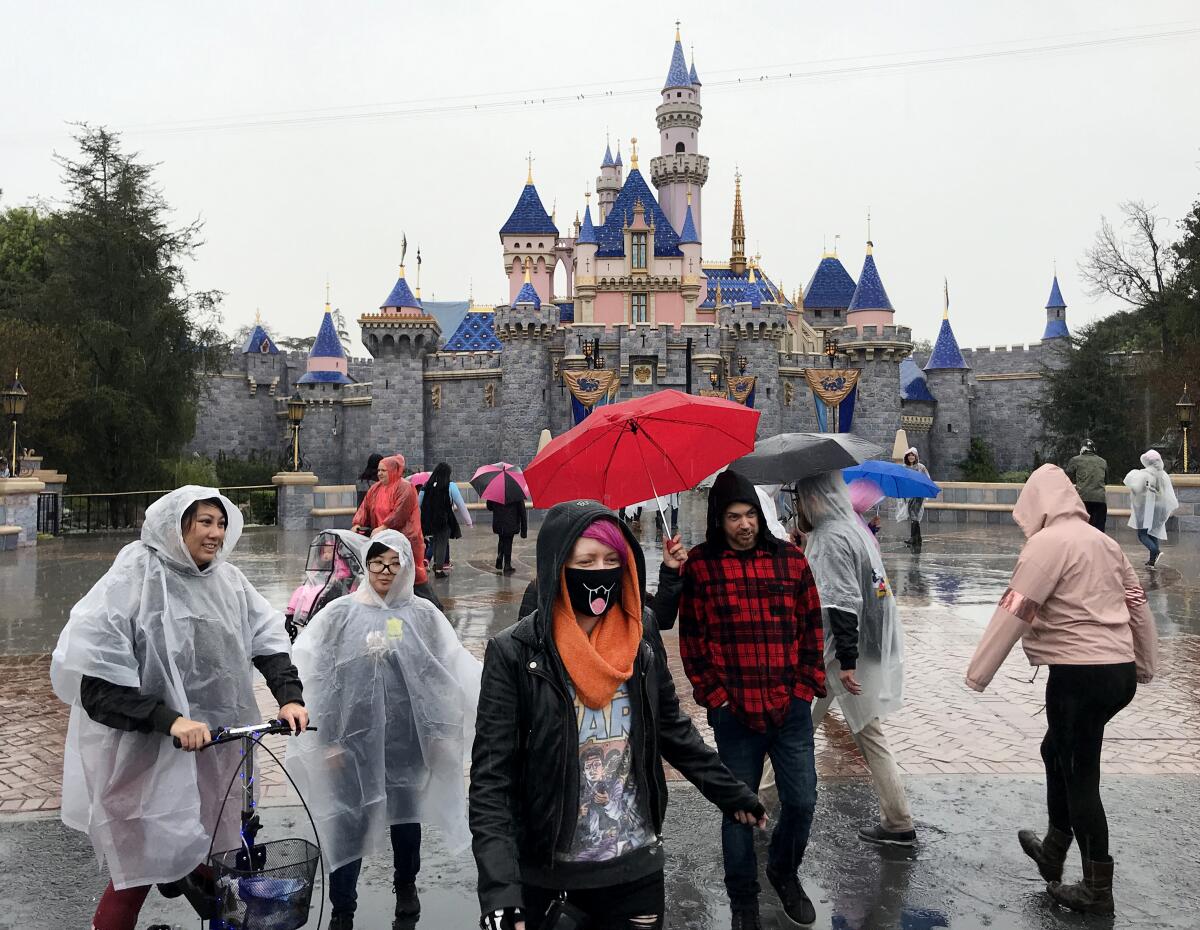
[[287, 530, 482, 870]]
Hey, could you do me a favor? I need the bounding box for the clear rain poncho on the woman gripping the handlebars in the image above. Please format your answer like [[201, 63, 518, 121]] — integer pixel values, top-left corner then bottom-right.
[[50, 485, 289, 888]]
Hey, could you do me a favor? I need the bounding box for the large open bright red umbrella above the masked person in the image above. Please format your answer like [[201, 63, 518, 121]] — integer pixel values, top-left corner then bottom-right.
[[524, 391, 760, 509]]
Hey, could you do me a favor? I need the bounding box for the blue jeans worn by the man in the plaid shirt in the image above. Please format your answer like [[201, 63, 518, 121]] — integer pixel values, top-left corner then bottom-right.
[[708, 697, 817, 908]]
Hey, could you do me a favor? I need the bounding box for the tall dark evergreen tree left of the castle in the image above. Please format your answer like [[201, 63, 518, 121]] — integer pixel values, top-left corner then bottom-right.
[[0, 126, 227, 491]]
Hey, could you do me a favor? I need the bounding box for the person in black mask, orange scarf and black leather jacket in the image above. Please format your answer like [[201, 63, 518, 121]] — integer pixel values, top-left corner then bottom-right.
[[468, 500, 766, 930]]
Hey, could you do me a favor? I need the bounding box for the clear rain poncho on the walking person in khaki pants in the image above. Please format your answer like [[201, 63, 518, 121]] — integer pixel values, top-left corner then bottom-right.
[[796, 472, 904, 733]]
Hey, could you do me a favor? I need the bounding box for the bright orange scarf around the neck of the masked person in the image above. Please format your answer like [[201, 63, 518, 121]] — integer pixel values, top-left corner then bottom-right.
[[553, 547, 642, 710]]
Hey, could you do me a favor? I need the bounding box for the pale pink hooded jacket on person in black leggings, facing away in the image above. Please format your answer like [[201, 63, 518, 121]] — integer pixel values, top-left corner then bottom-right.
[[967, 464, 1158, 691]]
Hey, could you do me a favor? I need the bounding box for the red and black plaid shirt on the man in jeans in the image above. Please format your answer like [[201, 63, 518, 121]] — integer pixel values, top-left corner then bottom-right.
[[679, 542, 826, 732]]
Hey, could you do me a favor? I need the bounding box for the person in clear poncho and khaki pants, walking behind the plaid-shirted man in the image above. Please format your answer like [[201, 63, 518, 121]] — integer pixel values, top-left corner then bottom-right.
[[796, 472, 917, 846]]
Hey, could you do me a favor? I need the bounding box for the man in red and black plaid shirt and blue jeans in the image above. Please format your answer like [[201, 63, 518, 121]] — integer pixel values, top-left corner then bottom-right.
[[664, 472, 826, 930]]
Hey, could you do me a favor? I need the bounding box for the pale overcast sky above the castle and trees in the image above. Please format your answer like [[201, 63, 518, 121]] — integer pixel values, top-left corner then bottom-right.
[[0, 0, 1200, 354]]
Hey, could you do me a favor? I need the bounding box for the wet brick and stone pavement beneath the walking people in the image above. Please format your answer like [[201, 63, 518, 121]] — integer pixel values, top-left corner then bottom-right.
[[0, 506, 1200, 930]]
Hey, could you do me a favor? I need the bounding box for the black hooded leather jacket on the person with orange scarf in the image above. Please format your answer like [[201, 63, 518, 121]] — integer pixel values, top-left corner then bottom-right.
[[470, 500, 762, 913]]
